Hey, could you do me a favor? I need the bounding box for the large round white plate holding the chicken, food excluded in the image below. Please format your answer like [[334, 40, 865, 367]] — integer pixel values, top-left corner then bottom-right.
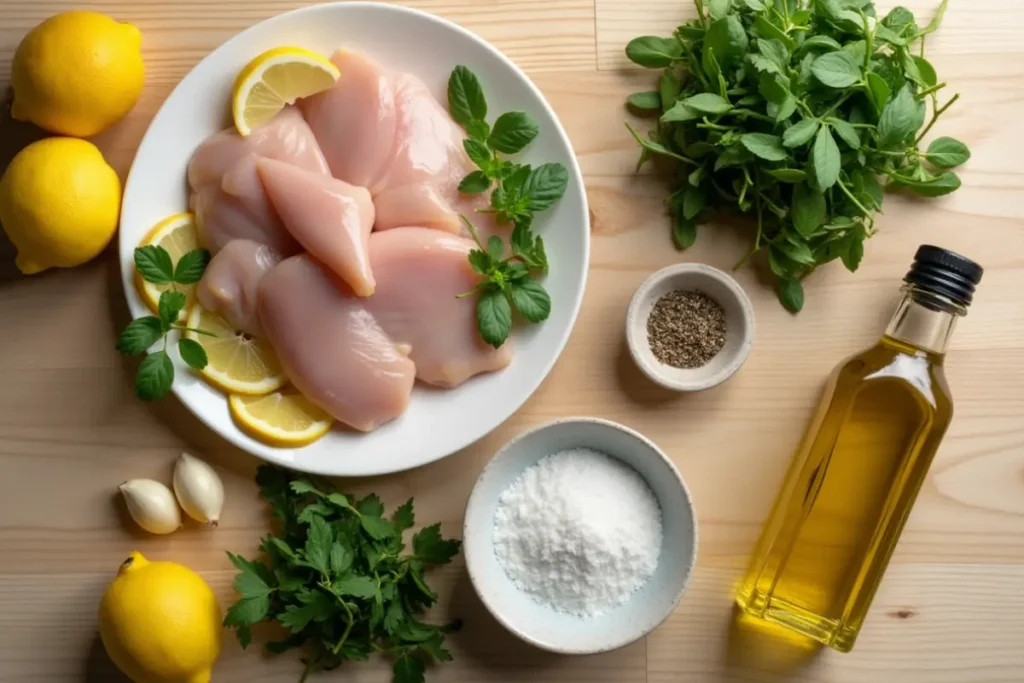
[[120, 2, 590, 476]]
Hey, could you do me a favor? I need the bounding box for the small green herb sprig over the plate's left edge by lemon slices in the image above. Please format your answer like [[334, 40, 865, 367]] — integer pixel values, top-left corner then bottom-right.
[[117, 245, 213, 400]]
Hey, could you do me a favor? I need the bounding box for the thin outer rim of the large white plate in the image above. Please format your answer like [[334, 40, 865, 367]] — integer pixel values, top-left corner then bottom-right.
[[118, 1, 592, 477]]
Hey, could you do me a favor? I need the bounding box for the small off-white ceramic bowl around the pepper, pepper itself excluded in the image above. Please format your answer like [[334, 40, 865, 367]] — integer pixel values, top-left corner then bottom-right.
[[626, 263, 754, 391]]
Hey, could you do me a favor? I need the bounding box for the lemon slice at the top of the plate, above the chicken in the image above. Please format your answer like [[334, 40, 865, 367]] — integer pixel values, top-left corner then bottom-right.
[[231, 47, 341, 135]]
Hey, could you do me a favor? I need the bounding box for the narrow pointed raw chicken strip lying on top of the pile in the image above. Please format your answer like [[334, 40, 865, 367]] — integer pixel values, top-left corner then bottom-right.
[[256, 159, 374, 296]]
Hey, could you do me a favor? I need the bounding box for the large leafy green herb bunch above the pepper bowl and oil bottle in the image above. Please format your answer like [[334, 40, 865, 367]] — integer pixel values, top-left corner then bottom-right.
[[626, 0, 970, 312]]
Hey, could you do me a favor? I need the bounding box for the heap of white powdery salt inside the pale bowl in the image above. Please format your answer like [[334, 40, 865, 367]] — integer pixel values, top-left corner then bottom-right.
[[495, 449, 662, 616]]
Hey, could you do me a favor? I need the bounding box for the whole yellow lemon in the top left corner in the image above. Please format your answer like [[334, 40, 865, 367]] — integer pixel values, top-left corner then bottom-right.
[[10, 10, 145, 137]]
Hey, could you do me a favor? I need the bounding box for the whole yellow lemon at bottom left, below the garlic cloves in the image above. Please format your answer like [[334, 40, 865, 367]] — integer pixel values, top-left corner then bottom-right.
[[99, 552, 221, 683]]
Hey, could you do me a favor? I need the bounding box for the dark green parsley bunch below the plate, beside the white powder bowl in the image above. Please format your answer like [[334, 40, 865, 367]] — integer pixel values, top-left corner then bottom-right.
[[224, 465, 461, 683]]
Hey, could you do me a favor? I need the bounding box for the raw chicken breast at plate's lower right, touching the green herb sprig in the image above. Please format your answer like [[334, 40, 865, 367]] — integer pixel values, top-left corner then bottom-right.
[[366, 227, 512, 387]]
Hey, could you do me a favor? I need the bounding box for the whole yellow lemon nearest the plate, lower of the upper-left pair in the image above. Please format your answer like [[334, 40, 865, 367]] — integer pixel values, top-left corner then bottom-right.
[[0, 137, 121, 274]]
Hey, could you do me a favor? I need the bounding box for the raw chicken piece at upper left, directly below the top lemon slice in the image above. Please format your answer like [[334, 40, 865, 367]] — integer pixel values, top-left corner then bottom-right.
[[188, 108, 330, 256]]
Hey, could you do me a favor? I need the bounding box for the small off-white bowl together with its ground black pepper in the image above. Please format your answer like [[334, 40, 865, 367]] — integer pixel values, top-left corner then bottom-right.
[[626, 263, 754, 391]]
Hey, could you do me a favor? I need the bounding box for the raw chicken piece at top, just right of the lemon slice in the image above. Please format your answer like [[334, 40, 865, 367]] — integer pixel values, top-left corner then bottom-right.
[[299, 49, 395, 188]]
